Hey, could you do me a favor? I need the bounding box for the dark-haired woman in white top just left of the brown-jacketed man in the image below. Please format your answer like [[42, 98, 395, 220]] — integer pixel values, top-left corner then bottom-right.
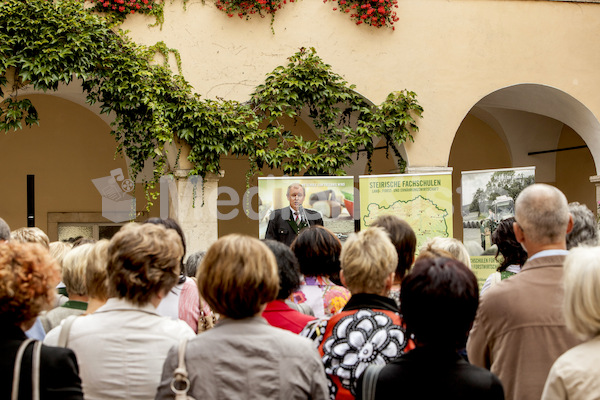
[[481, 217, 527, 294]]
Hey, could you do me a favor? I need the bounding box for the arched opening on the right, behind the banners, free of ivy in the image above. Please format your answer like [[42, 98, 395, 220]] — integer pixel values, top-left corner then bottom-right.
[[448, 84, 600, 239]]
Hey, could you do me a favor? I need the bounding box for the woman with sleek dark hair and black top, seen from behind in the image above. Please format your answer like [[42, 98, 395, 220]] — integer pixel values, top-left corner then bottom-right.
[[356, 258, 504, 400]]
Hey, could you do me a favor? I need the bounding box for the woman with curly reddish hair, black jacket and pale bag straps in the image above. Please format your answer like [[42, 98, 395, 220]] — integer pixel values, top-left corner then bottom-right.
[[0, 242, 83, 400]]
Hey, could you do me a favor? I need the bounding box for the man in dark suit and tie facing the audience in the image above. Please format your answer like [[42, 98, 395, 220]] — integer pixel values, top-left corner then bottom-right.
[[265, 183, 323, 246]]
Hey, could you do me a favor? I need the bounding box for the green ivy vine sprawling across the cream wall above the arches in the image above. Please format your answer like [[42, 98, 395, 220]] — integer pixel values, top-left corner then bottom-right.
[[0, 0, 423, 209]]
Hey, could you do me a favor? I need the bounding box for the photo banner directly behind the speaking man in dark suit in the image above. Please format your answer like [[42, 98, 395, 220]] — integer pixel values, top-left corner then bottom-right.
[[258, 176, 355, 240]]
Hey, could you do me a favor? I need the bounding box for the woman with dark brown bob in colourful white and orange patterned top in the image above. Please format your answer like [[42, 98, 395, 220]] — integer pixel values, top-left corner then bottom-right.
[[291, 225, 350, 318]]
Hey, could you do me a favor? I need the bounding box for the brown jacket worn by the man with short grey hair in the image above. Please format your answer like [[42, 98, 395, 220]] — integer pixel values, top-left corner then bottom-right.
[[467, 255, 581, 400]]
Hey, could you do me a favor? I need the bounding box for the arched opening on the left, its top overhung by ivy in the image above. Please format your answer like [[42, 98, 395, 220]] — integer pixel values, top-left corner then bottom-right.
[[0, 94, 157, 240]]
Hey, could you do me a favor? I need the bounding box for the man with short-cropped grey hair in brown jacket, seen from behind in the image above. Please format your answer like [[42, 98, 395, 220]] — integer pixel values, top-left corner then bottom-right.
[[467, 184, 580, 400]]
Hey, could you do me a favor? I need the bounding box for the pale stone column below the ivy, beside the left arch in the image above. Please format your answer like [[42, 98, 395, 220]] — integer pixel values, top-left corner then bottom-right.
[[160, 170, 223, 254]]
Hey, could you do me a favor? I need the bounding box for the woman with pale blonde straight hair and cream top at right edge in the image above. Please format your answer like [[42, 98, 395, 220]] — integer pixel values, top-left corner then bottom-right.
[[542, 247, 600, 400]]
